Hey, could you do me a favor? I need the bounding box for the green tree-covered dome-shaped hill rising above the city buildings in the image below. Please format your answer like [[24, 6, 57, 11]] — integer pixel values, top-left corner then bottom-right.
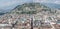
[[10, 3, 50, 14]]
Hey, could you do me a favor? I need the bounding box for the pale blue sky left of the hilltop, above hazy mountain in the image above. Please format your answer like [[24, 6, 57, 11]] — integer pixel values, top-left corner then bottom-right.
[[0, 0, 32, 9]]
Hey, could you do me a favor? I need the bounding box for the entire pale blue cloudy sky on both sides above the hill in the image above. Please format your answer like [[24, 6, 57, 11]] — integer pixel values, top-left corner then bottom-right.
[[0, 0, 60, 9]]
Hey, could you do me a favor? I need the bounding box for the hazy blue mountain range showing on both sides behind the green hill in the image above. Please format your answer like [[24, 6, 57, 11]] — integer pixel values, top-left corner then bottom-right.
[[0, 3, 60, 13]]
